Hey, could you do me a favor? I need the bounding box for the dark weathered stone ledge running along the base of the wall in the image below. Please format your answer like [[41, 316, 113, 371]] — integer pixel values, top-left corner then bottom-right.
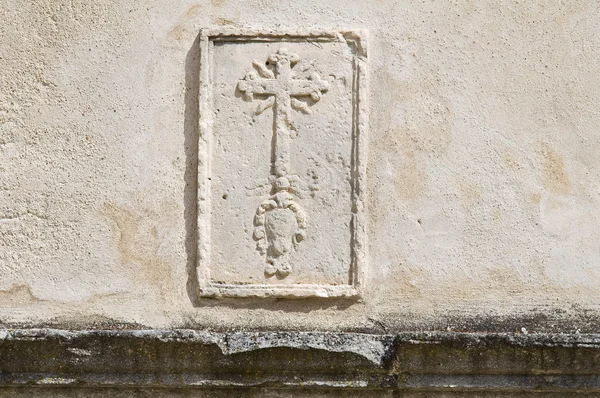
[[0, 329, 600, 393]]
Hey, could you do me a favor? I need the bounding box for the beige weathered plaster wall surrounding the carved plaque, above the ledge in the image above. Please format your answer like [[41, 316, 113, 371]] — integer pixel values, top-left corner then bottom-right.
[[0, 0, 600, 332]]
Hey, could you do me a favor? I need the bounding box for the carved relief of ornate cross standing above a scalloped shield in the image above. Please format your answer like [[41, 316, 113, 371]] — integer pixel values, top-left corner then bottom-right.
[[237, 47, 329, 277]]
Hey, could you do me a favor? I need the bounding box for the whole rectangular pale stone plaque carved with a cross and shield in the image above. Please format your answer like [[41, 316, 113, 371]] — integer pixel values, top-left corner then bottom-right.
[[198, 30, 368, 297]]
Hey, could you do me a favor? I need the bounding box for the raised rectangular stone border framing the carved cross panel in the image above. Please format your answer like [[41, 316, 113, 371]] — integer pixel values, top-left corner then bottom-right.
[[197, 29, 368, 298]]
